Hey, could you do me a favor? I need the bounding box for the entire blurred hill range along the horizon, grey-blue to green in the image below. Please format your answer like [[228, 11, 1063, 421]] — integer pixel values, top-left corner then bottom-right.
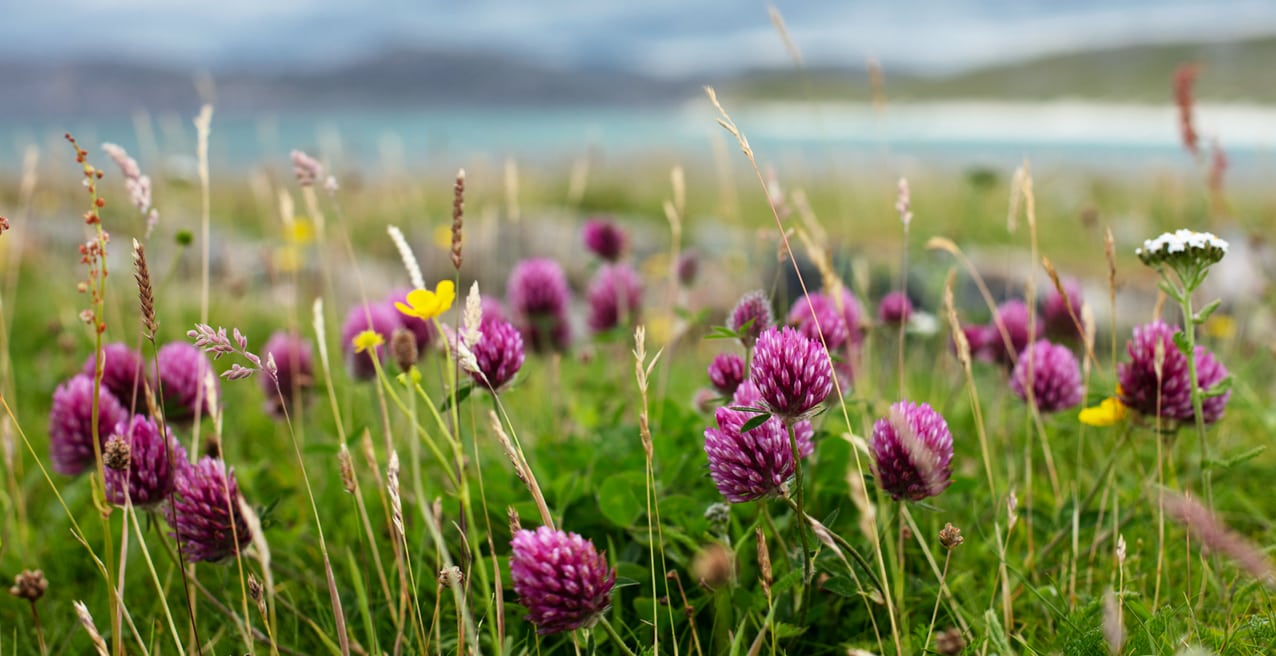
[[7, 37, 1276, 119]]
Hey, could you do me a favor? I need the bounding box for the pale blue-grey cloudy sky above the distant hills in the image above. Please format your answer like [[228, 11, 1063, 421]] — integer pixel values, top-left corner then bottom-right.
[[9, 0, 1276, 75]]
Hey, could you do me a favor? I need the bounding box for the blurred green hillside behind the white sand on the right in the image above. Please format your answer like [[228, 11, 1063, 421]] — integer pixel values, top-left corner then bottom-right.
[[720, 36, 1276, 102]]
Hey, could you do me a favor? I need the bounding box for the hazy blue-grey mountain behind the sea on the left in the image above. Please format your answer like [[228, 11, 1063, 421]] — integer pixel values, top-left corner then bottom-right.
[[0, 51, 699, 117]]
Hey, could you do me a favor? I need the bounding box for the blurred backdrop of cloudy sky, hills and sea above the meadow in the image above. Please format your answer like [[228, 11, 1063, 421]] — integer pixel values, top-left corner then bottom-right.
[[0, 0, 1276, 180]]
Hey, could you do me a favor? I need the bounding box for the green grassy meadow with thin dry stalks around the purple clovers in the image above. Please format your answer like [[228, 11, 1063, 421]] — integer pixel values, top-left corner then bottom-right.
[[0, 102, 1276, 655]]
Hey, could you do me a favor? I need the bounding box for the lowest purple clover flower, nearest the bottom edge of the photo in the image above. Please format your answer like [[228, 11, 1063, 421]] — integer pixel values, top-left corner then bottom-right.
[[509, 526, 616, 636]]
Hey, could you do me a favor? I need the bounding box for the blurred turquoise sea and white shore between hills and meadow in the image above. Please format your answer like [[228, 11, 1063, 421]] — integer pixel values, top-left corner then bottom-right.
[[0, 101, 1276, 179]]
